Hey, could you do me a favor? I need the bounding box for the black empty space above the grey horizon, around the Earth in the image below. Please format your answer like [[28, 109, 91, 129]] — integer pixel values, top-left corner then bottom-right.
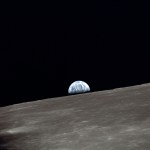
[[0, 0, 150, 106]]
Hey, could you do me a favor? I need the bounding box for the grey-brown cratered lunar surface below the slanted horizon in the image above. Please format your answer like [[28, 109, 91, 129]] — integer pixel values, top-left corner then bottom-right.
[[0, 84, 150, 150]]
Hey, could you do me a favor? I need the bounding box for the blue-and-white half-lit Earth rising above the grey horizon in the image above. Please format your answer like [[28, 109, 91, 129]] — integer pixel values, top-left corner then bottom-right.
[[68, 81, 90, 94]]
